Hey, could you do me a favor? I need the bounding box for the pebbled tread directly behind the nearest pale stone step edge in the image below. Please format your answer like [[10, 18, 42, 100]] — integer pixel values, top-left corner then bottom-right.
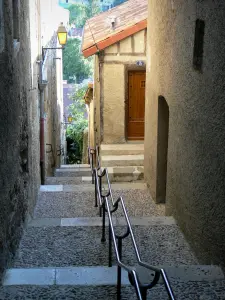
[[14, 224, 198, 268]]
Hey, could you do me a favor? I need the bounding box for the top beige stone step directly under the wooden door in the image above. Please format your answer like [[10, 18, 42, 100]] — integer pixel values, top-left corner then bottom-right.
[[100, 143, 144, 156]]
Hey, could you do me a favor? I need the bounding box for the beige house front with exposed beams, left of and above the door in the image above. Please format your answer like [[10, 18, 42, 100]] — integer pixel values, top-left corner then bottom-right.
[[93, 30, 146, 144]]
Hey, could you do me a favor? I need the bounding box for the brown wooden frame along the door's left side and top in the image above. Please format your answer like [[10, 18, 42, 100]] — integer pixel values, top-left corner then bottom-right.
[[124, 64, 146, 142]]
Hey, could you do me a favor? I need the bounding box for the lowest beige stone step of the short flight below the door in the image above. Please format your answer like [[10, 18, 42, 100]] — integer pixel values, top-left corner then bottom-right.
[[104, 166, 144, 182]]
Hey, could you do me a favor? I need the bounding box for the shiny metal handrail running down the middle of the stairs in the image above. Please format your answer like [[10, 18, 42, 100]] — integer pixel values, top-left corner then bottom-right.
[[89, 147, 175, 300]]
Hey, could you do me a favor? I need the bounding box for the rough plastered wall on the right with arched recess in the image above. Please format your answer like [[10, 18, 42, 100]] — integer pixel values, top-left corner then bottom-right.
[[145, 0, 225, 265]]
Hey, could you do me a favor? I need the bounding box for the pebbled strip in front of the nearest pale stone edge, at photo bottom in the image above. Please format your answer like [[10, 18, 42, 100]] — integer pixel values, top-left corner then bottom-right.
[[0, 281, 225, 300]]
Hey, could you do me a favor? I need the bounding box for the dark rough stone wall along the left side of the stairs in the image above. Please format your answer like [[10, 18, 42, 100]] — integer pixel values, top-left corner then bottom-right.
[[0, 0, 39, 278]]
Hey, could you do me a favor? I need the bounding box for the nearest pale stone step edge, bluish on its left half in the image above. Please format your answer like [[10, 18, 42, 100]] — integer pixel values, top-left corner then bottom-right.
[[3, 265, 224, 286]]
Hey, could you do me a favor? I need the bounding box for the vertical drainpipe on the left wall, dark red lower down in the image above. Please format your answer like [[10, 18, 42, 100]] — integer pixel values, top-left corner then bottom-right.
[[38, 61, 48, 185]]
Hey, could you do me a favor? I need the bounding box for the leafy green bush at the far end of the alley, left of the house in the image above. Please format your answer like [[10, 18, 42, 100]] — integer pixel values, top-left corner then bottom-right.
[[66, 86, 88, 163]]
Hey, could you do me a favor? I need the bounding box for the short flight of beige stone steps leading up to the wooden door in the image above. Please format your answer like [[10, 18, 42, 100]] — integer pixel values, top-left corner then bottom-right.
[[100, 143, 144, 182]]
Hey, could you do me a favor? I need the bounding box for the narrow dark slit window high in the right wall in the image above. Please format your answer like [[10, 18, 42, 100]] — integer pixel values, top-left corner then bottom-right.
[[193, 19, 205, 71]]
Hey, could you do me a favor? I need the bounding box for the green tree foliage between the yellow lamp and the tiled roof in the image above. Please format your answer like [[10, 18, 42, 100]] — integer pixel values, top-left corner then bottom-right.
[[63, 39, 93, 83]]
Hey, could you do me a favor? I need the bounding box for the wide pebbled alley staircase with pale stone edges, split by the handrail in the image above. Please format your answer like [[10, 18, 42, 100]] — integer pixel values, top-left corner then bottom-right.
[[0, 165, 225, 300]]
